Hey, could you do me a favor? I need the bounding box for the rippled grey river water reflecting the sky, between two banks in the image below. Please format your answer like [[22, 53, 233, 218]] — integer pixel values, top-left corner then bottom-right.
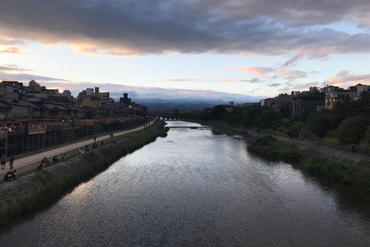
[[0, 121, 370, 247]]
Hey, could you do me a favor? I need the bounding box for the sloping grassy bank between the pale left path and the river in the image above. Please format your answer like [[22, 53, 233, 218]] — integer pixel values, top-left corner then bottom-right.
[[0, 121, 168, 226]]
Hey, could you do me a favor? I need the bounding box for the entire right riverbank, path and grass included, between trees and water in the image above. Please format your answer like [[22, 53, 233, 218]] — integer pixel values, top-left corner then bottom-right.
[[184, 120, 370, 190]]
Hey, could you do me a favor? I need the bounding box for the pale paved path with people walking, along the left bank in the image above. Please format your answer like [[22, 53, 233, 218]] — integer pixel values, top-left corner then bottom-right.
[[0, 120, 155, 178]]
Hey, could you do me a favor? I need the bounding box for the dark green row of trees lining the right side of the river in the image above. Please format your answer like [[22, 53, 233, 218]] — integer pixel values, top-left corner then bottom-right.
[[181, 92, 370, 148]]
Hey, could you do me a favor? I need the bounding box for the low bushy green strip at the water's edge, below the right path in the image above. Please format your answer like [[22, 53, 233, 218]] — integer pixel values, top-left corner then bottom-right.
[[248, 136, 370, 190]]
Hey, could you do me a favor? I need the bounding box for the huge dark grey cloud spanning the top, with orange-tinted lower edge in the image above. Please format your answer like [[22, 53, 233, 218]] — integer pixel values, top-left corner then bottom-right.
[[0, 0, 370, 56]]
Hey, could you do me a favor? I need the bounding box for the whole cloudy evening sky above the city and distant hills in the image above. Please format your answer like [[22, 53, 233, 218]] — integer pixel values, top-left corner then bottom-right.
[[0, 0, 370, 103]]
